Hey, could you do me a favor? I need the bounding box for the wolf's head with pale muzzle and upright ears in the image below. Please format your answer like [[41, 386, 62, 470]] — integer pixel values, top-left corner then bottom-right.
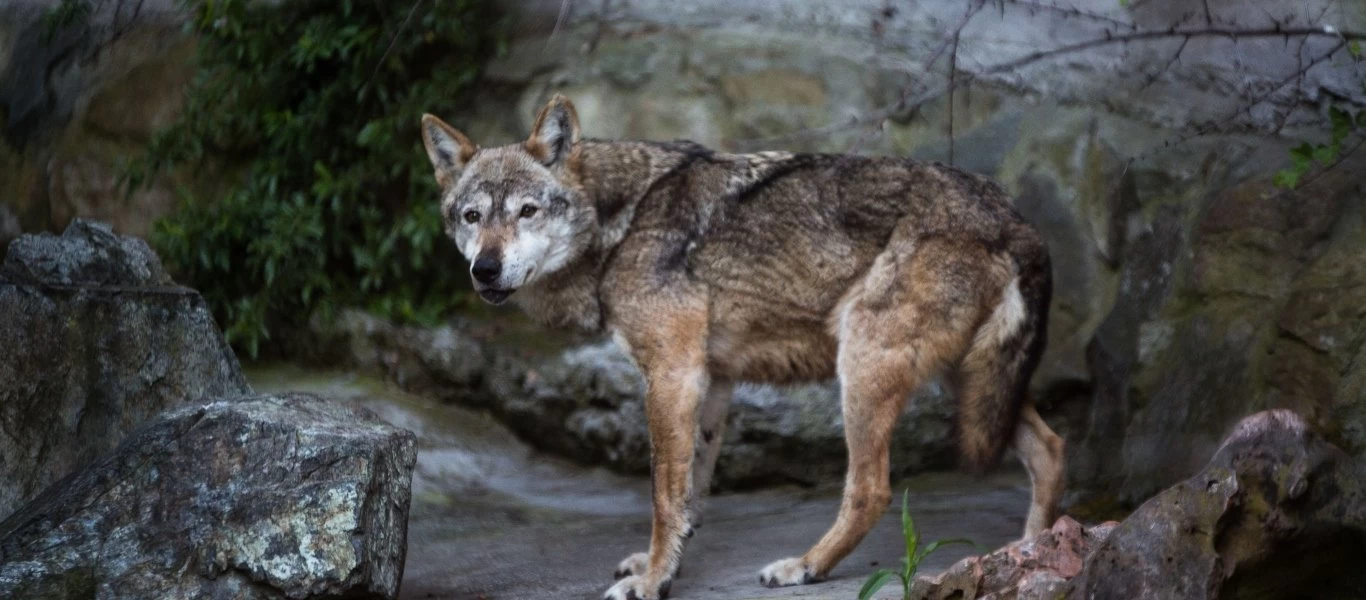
[[422, 94, 597, 305]]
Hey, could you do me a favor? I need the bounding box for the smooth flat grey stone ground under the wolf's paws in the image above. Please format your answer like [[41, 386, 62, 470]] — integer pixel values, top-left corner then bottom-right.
[[247, 368, 1029, 600]]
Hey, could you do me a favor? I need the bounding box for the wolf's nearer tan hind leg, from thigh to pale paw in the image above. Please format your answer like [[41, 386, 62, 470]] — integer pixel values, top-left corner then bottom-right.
[[759, 241, 989, 586]]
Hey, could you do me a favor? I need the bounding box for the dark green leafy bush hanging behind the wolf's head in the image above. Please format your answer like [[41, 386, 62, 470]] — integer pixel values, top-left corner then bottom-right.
[[126, 0, 503, 357]]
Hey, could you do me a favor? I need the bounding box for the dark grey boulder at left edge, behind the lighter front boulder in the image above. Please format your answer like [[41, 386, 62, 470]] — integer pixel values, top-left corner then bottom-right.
[[0, 220, 250, 517]]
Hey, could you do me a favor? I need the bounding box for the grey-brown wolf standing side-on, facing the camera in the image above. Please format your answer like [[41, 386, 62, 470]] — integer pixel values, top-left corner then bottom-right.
[[422, 94, 1063, 600]]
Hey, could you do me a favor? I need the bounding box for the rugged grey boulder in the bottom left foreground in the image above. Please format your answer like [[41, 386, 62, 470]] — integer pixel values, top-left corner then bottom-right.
[[0, 394, 417, 600]]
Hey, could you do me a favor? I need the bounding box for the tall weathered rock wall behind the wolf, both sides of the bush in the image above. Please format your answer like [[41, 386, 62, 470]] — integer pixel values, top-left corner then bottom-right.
[[0, 0, 1366, 503]]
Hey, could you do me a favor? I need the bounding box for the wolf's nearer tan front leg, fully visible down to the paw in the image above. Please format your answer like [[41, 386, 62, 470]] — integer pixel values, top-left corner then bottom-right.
[[604, 305, 710, 600]]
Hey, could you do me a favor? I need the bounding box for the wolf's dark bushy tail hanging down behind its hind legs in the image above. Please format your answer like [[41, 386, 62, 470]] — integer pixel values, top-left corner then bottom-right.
[[958, 243, 1053, 472]]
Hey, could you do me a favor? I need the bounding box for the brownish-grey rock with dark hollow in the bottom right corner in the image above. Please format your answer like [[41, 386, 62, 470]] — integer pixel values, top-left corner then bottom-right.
[[1067, 410, 1366, 600]]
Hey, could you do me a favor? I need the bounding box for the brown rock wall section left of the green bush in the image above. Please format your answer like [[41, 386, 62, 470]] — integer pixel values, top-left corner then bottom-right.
[[0, 0, 194, 242]]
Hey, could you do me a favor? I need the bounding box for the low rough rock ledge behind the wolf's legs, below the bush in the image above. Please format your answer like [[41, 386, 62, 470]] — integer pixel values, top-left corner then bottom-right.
[[314, 312, 956, 488]]
